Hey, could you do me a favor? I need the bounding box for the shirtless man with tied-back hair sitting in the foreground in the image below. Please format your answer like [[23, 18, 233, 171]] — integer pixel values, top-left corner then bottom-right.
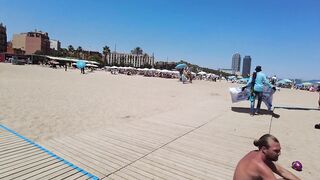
[[233, 134, 299, 180]]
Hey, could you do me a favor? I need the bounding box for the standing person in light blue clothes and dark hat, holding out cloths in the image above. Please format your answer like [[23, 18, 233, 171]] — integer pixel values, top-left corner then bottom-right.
[[242, 66, 275, 114]]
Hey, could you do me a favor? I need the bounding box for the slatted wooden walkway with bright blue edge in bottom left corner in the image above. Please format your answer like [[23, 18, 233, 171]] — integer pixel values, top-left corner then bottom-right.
[[0, 125, 98, 180]]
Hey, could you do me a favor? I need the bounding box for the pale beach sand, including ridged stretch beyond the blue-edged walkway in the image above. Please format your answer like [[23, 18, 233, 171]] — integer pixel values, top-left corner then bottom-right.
[[0, 63, 320, 179]]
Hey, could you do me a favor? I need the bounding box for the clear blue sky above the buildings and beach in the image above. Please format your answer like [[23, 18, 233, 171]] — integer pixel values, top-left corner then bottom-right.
[[0, 0, 320, 80]]
